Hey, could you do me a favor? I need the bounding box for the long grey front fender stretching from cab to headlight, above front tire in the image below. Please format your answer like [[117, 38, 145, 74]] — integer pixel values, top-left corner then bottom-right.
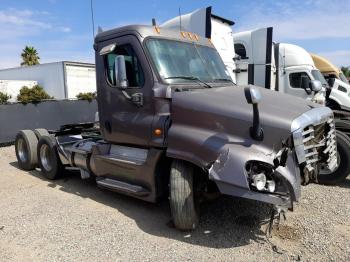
[[166, 125, 300, 204]]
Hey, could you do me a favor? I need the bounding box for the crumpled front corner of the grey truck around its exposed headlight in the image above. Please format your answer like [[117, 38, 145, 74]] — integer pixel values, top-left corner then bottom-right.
[[209, 145, 301, 209]]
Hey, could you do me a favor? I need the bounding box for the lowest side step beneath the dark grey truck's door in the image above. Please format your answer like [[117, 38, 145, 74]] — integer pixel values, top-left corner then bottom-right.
[[96, 178, 151, 197]]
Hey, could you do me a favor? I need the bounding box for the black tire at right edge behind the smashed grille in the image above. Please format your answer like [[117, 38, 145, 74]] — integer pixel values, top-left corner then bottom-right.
[[318, 131, 350, 185]]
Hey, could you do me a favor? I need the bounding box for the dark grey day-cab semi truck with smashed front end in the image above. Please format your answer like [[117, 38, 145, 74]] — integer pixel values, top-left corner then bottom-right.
[[15, 25, 337, 230]]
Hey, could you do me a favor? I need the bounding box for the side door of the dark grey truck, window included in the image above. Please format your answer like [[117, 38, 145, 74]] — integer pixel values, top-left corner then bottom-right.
[[96, 35, 154, 146]]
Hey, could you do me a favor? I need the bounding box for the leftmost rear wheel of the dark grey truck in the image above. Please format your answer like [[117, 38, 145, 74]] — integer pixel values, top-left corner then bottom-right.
[[15, 130, 38, 171]]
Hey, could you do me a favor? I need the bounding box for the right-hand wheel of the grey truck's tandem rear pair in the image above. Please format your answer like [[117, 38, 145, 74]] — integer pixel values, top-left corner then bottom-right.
[[37, 136, 64, 180]]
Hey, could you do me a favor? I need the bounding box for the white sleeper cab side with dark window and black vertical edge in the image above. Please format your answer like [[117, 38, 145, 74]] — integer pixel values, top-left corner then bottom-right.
[[233, 27, 274, 89]]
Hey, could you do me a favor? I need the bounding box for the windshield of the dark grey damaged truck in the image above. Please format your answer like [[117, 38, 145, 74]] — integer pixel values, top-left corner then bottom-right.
[[146, 39, 232, 84]]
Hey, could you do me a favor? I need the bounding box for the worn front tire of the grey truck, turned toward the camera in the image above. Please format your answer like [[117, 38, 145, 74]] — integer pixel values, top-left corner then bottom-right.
[[170, 160, 199, 230]]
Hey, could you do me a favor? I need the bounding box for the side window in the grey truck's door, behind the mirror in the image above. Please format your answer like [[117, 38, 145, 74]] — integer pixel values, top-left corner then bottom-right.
[[105, 45, 145, 87]]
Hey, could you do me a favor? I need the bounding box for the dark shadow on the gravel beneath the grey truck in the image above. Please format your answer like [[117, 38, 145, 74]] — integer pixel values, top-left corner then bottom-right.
[[10, 162, 270, 248]]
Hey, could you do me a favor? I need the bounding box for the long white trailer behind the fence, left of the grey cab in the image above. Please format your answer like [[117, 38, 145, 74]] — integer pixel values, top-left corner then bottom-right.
[[0, 61, 96, 99]]
